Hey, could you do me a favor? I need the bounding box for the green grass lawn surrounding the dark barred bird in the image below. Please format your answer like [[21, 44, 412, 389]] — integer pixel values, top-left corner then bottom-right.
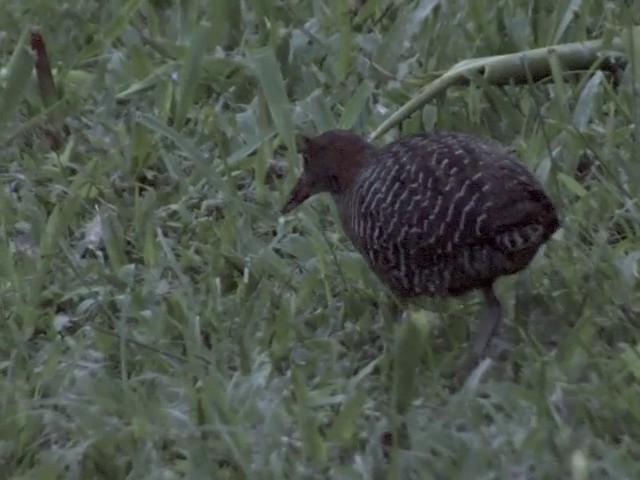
[[0, 0, 640, 480]]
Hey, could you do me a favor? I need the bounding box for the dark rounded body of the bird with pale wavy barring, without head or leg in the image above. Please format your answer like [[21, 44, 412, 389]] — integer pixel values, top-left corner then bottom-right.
[[341, 132, 558, 297]]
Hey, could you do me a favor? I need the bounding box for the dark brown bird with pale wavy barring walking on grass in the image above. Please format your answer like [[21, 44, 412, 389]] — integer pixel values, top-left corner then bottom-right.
[[280, 129, 560, 360]]
